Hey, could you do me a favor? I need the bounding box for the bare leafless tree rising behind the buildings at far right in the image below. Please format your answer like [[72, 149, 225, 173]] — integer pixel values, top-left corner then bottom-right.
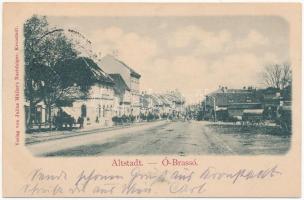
[[263, 63, 291, 89]]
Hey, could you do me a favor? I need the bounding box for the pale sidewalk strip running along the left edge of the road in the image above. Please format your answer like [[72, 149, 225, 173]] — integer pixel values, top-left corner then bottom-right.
[[25, 120, 162, 145]]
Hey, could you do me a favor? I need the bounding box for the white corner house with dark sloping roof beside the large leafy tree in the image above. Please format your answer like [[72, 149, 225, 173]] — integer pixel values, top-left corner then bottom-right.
[[60, 58, 115, 127]]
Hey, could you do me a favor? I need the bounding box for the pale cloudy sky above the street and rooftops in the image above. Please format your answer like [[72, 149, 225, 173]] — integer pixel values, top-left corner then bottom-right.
[[48, 16, 290, 103]]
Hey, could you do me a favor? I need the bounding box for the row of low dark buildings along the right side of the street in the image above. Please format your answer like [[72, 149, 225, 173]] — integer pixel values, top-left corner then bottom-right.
[[200, 86, 291, 121]]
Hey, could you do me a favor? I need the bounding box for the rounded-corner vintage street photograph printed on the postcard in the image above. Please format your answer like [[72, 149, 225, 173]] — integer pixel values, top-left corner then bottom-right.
[[22, 15, 292, 157]]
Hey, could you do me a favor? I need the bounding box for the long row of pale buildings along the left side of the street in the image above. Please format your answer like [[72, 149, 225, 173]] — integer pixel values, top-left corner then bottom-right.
[[25, 55, 185, 128]]
